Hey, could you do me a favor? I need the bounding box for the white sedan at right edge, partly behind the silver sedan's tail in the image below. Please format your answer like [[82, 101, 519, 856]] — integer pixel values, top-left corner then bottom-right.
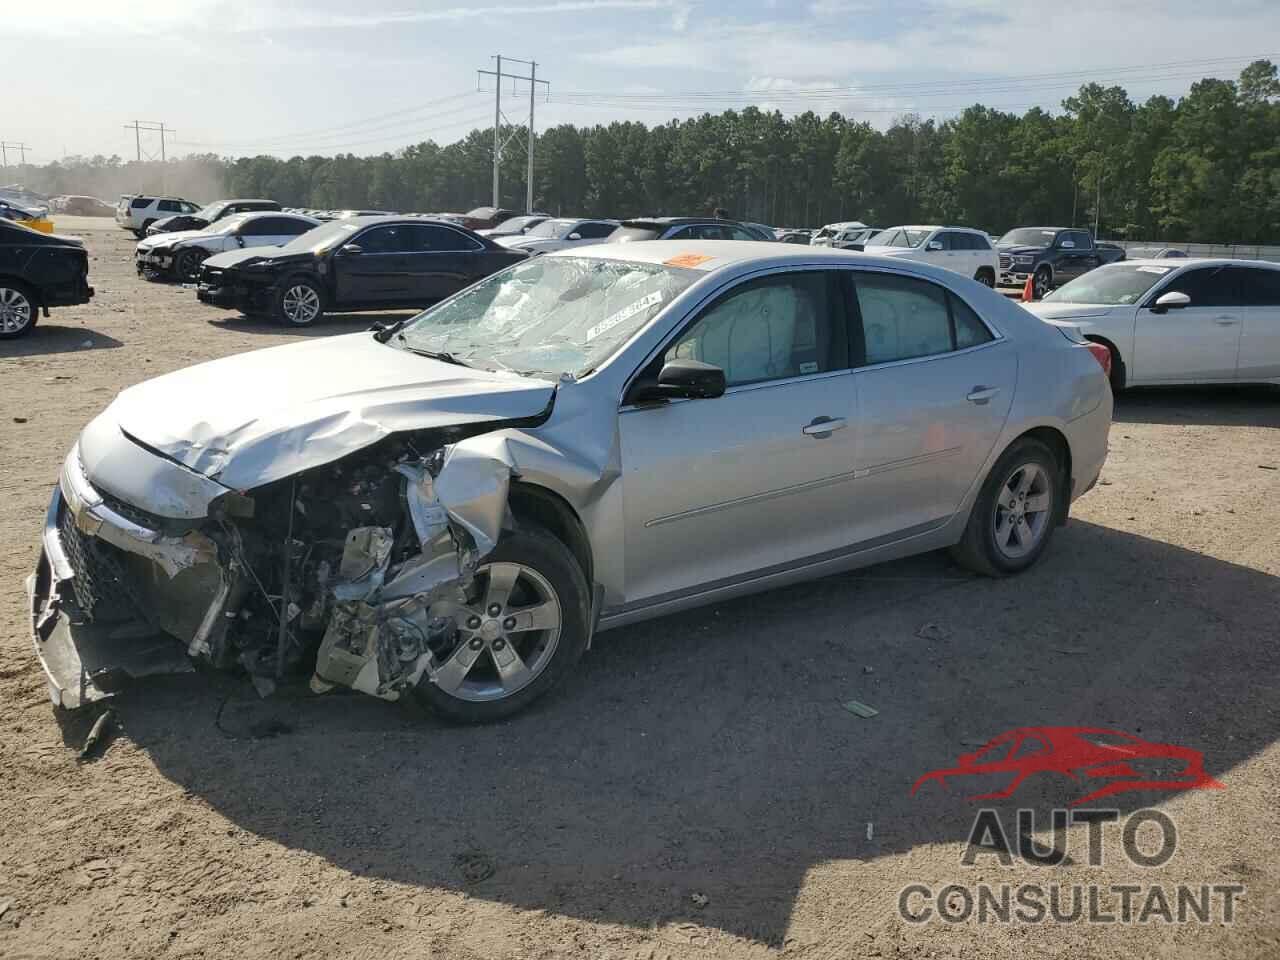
[[1025, 260, 1280, 389]]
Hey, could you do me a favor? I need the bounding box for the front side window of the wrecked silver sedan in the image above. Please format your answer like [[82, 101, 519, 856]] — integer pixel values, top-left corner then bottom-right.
[[664, 271, 847, 387]]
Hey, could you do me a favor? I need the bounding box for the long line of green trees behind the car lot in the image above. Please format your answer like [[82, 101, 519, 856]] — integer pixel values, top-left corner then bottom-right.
[[26, 60, 1280, 243]]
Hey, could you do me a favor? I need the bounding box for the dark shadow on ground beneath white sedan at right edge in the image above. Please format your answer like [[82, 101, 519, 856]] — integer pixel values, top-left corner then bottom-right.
[[1112, 384, 1280, 426]]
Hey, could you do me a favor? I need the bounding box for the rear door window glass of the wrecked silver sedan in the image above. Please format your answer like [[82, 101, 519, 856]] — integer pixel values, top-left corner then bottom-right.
[[855, 273, 972, 364]]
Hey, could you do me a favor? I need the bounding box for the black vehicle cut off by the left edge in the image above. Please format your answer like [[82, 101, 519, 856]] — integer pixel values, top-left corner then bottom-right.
[[0, 219, 93, 340]]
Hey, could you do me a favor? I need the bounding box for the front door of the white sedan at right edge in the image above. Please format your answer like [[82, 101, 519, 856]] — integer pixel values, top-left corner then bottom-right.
[[1129, 266, 1244, 383]]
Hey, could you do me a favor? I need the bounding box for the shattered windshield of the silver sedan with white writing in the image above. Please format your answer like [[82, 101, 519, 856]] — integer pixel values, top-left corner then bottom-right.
[[396, 256, 700, 378]]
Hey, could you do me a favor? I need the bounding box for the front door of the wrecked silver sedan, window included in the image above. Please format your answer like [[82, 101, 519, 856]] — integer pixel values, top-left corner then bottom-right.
[[618, 270, 856, 603]]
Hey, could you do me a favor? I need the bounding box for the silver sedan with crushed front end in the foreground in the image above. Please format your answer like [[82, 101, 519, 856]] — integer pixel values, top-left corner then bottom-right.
[[28, 241, 1111, 722]]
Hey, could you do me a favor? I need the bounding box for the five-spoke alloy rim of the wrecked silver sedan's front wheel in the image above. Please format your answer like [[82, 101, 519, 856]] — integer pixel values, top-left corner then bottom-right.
[[433, 562, 564, 701]]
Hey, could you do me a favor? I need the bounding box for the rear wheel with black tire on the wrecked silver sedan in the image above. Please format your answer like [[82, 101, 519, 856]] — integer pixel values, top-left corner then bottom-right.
[[951, 436, 1066, 577]]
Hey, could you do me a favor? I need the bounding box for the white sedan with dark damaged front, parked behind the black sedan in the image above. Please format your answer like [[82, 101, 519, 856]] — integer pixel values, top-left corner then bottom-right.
[[134, 211, 320, 280]]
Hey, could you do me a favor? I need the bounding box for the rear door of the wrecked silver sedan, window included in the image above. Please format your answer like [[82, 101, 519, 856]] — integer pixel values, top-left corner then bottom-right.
[[850, 270, 1018, 540]]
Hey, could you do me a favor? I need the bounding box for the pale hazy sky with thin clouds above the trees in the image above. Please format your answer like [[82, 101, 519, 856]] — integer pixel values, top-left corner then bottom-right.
[[0, 0, 1280, 163]]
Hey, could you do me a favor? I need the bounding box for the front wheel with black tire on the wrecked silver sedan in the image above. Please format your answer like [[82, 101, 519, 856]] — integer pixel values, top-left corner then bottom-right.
[[411, 524, 590, 723]]
